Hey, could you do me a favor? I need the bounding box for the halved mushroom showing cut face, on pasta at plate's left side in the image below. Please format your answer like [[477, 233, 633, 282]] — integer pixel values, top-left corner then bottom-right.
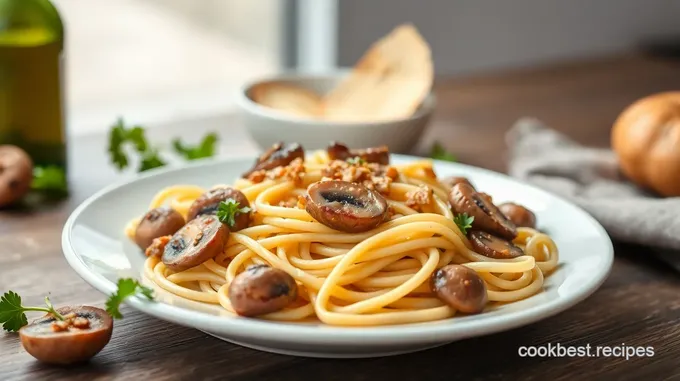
[[161, 215, 229, 271]]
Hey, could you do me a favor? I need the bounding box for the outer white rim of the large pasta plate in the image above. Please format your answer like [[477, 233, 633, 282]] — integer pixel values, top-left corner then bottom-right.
[[62, 154, 614, 345]]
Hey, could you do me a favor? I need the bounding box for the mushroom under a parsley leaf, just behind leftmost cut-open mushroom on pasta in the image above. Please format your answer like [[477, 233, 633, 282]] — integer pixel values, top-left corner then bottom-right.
[[187, 187, 250, 231]]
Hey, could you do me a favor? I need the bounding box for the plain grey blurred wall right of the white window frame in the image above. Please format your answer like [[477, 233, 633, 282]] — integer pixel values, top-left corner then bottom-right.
[[337, 0, 680, 74]]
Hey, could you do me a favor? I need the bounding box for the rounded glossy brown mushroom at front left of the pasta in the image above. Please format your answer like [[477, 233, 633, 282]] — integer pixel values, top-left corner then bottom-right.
[[229, 265, 297, 316]]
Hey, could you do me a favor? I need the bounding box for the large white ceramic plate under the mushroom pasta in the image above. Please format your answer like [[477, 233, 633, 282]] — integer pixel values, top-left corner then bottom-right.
[[62, 156, 613, 357]]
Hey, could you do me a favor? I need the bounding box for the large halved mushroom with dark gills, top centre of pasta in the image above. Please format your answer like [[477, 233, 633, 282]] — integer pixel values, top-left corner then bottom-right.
[[305, 180, 388, 233]]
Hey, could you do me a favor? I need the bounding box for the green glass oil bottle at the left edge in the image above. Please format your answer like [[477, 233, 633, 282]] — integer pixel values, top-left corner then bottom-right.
[[0, 0, 67, 171]]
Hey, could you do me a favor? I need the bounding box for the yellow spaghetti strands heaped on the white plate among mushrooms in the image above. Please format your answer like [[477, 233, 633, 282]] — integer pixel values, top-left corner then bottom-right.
[[125, 147, 558, 326]]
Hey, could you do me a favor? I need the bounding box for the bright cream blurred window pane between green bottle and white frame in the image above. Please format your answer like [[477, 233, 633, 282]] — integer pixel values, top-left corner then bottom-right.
[[53, 0, 286, 134]]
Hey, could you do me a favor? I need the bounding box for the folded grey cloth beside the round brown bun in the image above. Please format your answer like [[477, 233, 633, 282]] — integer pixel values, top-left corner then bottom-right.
[[506, 118, 680, 251]]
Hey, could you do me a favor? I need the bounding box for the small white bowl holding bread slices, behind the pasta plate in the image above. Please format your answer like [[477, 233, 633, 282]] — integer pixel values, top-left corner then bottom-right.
[[236, 70, 436, 153]]
